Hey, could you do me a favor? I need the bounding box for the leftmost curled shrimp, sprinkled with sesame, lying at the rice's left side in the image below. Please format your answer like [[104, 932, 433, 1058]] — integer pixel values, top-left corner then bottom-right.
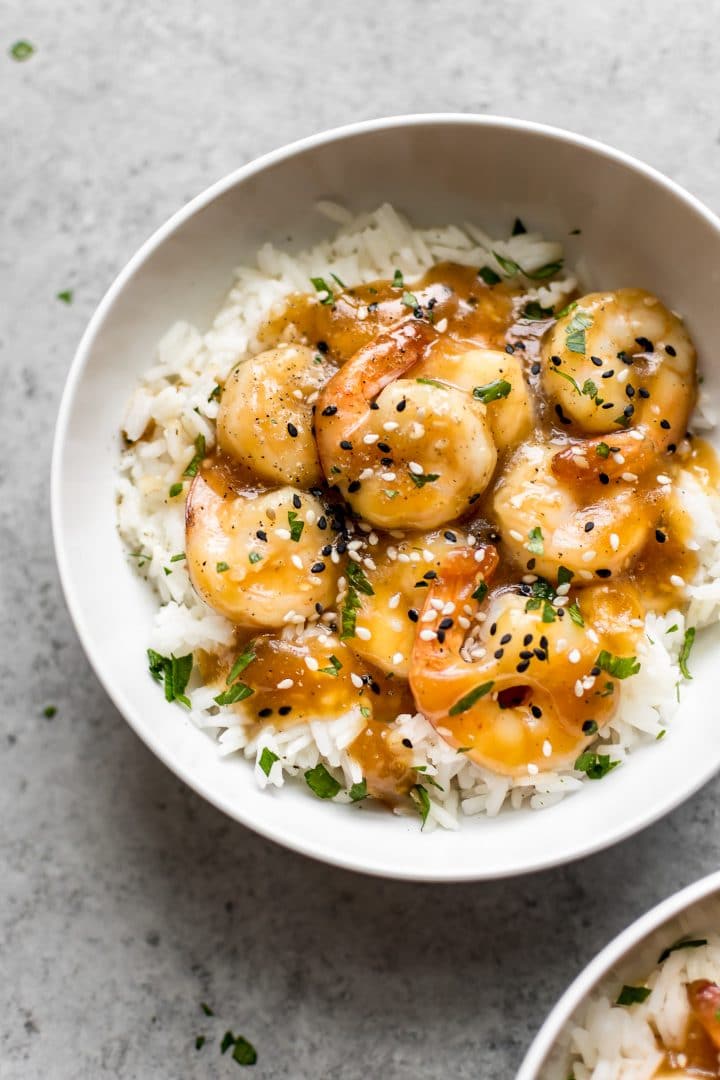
[[186, 473, 337, 626]]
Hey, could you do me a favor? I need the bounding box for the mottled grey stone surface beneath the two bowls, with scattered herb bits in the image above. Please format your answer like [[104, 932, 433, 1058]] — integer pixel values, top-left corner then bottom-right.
[[0, 0, 720, 1080]]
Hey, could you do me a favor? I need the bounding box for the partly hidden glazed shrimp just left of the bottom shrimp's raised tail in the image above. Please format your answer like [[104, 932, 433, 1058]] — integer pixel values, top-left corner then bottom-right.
[[348, 528, 467, 678]]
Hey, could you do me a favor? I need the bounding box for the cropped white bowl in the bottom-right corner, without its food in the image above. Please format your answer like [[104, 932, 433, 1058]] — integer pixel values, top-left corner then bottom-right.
[[516, 872, 720, 1080]]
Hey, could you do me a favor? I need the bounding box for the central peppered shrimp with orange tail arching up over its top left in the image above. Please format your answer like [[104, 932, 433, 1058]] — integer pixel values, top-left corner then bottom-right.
[[315, 320, 497, 529]]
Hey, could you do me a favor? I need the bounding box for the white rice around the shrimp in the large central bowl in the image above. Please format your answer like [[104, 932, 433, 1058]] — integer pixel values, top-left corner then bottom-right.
[[118, 203, 720, 828]]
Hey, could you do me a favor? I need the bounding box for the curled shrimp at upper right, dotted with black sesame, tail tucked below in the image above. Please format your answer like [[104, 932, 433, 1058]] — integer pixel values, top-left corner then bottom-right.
[[542, 288, 696, 478]]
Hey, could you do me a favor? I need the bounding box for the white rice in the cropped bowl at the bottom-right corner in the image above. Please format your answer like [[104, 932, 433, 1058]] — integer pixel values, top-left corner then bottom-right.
[[565, 928, 720, 1080]]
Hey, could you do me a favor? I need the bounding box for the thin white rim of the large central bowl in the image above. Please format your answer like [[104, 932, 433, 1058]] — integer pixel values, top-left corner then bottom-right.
[[50, 112, 720, 883]]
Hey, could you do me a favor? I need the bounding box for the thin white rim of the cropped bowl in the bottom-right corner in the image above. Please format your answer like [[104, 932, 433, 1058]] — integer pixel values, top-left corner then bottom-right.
[[515, 870, 720, 1080]]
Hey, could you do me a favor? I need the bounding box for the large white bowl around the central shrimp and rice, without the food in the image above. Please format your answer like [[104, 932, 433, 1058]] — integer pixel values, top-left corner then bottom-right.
[[52, 116, 720, 881]]
